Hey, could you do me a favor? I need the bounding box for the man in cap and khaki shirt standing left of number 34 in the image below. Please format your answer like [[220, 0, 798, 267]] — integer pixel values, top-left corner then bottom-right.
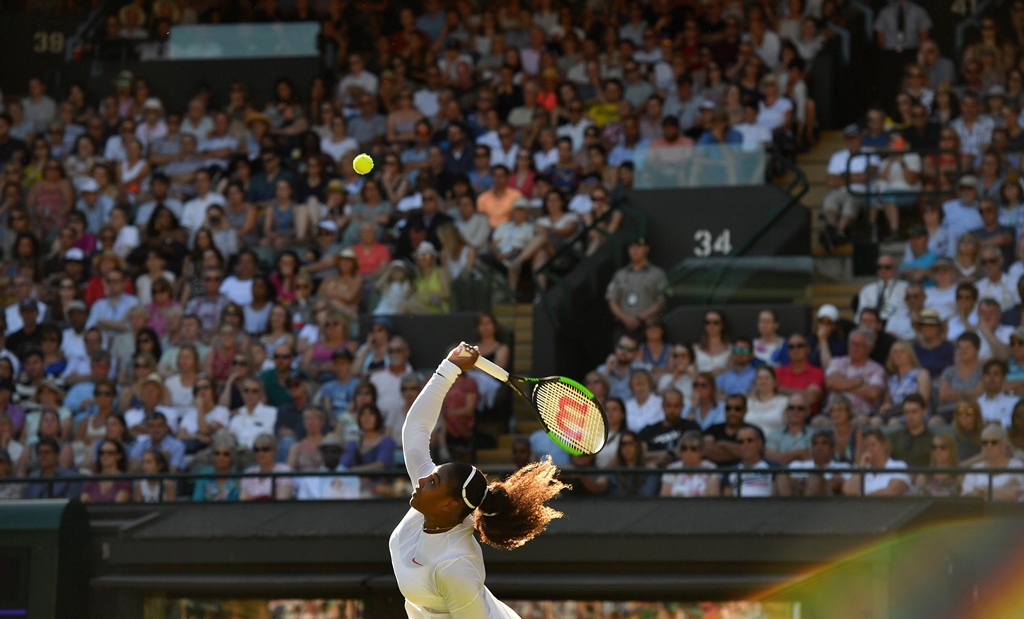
[[604, 238, 666, 334]]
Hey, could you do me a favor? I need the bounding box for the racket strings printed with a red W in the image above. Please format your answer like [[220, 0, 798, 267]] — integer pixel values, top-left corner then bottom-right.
[[534, 381, 607, 454]]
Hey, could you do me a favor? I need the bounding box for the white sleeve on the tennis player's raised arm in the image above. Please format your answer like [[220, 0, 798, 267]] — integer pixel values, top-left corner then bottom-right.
[[401, 359, 462, 486]]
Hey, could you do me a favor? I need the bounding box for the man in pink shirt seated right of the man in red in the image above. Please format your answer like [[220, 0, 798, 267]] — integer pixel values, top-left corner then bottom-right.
[[825, 327, 886, 416]]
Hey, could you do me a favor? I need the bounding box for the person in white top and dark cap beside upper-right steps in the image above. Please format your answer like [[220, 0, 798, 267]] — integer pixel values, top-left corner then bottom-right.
[[821, 124, 879, 242]]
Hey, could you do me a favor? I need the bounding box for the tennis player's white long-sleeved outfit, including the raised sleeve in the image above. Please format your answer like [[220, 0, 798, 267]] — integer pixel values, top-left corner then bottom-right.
[[388, 359, 520, 619]]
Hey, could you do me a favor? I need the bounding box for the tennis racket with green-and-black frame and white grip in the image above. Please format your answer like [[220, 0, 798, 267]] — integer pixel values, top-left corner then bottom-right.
[[464, 348, 608, 455]]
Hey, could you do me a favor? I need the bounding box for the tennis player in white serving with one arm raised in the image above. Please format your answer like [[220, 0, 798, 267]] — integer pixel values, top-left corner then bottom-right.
[[388, 342, 566, 619]]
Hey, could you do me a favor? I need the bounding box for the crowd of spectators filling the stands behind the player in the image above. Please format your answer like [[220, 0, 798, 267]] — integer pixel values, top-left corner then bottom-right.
[[6, 0, 1024, 501]]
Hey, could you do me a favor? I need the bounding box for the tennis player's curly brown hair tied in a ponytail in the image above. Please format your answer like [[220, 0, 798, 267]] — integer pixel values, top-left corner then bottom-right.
[[452, 456, 570, 550]]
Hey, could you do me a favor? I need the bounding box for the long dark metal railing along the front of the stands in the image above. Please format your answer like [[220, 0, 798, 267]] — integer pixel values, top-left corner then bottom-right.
[[0, 465, 1024, 503]]
